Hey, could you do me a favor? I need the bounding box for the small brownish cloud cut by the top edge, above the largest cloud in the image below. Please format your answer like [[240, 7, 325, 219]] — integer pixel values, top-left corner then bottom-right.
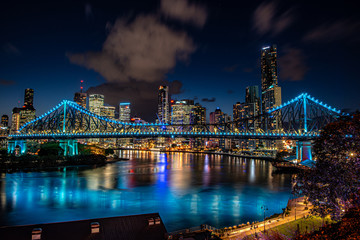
[[161, 0, 207, 27]]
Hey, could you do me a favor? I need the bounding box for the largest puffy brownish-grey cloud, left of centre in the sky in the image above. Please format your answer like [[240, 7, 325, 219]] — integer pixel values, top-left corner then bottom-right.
[[67, 15, 195, 82]]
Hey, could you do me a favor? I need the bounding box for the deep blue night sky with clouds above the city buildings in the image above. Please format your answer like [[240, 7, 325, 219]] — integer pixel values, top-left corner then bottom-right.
[[0, 0, 360, 121]]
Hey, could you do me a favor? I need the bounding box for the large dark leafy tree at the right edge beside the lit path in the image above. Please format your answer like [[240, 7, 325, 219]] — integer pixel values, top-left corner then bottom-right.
[[293, 114, 360, 219]]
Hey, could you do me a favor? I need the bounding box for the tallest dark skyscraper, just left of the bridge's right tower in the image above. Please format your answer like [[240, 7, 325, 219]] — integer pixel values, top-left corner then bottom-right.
[[261, 45, 281, 130]]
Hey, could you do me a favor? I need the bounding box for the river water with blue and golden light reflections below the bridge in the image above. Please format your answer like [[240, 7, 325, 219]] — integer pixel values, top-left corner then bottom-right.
[[0, 151, 291, 231]]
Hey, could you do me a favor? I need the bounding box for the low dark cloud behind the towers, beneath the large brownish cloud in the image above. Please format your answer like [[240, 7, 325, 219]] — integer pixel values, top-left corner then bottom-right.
[[87, 81, 182, 122]]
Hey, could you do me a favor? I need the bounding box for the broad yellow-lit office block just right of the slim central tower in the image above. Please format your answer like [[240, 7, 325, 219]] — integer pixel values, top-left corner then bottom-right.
[[171, 99, 194, 124]]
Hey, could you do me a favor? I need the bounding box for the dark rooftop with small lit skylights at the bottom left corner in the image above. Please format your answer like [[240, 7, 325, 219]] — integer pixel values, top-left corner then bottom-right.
[[0, 213, 167, 240]]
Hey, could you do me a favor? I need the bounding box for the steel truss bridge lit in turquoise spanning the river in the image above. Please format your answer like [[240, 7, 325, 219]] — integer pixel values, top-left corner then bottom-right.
[[8, 93, 346, 159]]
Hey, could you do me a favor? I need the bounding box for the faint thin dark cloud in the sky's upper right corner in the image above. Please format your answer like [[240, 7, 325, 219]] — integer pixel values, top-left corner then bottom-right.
[[303, 20, 360, 42]]
